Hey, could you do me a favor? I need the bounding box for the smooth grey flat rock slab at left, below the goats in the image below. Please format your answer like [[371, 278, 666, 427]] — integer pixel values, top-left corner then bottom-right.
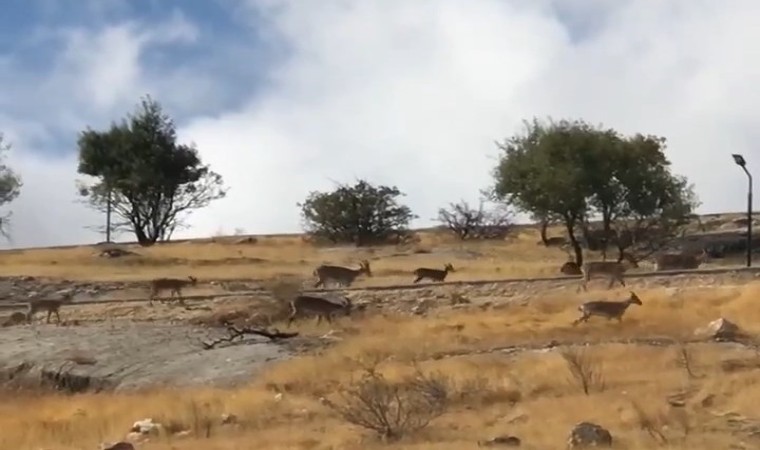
[[0, 321, 290, 390]]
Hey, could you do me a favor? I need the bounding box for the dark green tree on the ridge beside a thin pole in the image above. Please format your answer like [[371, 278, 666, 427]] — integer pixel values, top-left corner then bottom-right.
[[77, 97, 226, 246]]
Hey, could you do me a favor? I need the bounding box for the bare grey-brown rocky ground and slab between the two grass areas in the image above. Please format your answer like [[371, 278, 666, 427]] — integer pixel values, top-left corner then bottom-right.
[[0, 272, 756, 390]]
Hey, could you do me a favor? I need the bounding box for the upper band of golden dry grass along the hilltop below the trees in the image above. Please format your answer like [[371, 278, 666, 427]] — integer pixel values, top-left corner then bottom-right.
[[0, 229, 696, 285]]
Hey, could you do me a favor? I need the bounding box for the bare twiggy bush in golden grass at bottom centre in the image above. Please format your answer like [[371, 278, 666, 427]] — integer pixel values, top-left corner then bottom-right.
[[325, 367, 450, 439]]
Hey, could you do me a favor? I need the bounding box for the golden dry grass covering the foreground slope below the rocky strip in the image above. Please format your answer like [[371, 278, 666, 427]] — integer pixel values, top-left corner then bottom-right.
[[0, 283, 760, 450]]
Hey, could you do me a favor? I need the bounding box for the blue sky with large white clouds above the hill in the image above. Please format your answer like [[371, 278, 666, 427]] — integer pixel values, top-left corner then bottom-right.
[[0, 0, 760, 247]]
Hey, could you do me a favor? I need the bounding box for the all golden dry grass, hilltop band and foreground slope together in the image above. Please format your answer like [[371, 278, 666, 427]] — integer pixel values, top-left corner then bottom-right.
[[0, 222, 760, 450]]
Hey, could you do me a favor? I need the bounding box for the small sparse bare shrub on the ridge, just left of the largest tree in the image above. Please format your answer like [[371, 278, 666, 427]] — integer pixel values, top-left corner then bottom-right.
[[438, 201, 513, 241]]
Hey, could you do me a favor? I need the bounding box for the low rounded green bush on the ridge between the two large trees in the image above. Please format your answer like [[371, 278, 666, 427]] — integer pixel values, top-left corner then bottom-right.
[[298, 180, 417, 246]]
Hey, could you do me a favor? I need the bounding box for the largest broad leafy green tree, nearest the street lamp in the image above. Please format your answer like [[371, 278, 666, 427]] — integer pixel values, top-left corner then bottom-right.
[[492, 119, 698, 264]]
